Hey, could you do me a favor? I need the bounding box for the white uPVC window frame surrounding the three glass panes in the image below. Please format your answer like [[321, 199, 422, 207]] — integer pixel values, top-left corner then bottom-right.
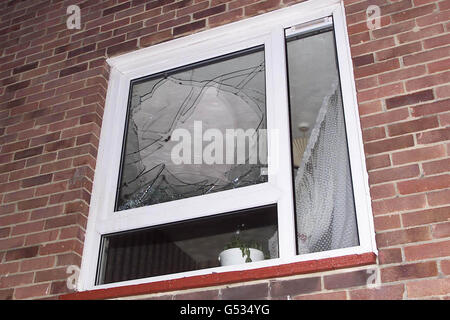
[[77, 0, 377, 291]]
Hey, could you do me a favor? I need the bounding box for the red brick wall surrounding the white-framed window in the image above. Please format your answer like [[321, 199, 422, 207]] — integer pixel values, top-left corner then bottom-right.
[[0, 0, 450, 299]]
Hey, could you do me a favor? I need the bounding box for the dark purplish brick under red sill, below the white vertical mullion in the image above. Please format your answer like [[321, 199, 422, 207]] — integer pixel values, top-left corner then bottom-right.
[[270, 277, 321, 298]]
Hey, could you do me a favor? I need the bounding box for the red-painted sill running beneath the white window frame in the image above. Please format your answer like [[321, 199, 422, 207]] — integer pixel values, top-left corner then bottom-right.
[[59, 252, 376, 300]]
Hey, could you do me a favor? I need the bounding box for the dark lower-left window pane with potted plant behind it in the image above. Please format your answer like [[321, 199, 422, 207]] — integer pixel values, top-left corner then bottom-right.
[[96, 205, 278, 284]]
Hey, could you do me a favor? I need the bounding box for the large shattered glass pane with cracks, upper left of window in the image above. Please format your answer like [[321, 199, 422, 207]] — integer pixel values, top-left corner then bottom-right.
[[116, 46, 267, 211]]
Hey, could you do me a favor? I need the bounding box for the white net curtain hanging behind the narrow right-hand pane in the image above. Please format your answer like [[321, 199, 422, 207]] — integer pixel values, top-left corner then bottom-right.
[[294, 83, 358, 254]]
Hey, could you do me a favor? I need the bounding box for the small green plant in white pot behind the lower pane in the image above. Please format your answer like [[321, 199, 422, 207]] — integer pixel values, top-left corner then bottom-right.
[[219, 232, 264, 266]]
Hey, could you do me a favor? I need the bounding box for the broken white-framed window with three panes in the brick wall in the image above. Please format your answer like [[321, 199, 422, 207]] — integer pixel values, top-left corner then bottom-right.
[[80, 0, 376, 290]]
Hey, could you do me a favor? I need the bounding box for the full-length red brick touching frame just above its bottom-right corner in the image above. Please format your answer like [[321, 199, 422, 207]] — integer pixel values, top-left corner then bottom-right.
[[376, 227, 431, 248]]
